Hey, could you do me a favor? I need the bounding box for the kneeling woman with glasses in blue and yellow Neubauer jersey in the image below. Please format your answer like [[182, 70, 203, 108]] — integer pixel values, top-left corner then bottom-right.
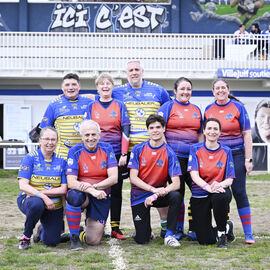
[[17, 127, 67, 250]]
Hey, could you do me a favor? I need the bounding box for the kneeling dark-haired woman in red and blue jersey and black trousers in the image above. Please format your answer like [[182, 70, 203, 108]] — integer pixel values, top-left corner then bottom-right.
[[188, 118, 235, 248]]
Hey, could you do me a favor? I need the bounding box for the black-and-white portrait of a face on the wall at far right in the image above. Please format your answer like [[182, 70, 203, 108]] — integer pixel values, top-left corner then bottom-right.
[[252, 99, 270, 171]]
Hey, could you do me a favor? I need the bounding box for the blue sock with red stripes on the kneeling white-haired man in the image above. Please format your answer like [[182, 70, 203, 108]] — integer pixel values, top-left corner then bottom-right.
[[66, 203, 82, 236]]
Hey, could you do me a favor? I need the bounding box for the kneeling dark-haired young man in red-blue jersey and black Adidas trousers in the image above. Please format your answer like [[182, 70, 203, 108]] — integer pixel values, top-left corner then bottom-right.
[[128, 114, 182, 247]]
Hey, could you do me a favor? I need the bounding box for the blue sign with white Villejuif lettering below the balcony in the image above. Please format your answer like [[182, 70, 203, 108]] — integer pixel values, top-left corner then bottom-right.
[[217, 68, 270, 79]]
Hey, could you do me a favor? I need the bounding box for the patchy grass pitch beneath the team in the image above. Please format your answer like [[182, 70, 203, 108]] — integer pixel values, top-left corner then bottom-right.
[[0, 174, 270, 270]]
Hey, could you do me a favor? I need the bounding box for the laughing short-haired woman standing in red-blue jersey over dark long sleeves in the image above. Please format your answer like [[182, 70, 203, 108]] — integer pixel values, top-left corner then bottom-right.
[[84, 73, 130, 239]]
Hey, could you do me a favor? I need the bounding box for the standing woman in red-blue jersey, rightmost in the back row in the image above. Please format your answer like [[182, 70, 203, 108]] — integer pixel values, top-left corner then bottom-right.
[[204, 79, 255, 244]]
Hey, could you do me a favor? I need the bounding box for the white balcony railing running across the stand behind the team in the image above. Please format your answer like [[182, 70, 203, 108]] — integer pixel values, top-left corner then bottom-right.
[[0, 32, 270, 77]]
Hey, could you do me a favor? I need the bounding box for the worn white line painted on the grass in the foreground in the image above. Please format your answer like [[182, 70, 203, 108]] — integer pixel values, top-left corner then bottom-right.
[[108, 238, 127, 270]]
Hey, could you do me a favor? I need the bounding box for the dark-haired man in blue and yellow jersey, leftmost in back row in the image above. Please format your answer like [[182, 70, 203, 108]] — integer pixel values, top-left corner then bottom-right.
[[40, 73, 92, 159]]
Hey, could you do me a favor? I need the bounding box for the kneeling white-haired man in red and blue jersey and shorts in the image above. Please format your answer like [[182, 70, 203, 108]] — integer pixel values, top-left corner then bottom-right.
[[66, 120, 118, 250]]
